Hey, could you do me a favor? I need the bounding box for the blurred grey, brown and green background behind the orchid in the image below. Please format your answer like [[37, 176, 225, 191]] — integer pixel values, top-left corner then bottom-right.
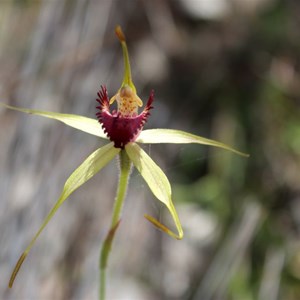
[[0, 0, 300, 300]]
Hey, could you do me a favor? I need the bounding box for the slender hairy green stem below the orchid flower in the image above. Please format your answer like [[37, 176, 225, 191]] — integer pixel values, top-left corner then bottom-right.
[[99, 150, 131, 300]]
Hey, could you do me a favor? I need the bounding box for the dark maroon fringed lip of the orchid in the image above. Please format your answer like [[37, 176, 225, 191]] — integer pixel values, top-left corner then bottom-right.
[[96, 86, 154, 149]]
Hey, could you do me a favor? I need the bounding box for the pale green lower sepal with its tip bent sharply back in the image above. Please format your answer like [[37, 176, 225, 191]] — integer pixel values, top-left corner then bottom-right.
[[125, 143, 183, 239]]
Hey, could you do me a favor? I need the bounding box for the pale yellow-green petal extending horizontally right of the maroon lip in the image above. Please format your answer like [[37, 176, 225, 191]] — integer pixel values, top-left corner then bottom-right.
[[136, 129, 249, 157]]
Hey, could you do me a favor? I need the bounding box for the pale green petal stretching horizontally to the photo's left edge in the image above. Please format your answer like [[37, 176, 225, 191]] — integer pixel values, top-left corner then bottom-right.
[[0, 103, 107, 139]]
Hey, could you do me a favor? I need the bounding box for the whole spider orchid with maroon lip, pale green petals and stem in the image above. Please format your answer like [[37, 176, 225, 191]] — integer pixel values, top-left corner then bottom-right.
[[2, 26, 248, 299]]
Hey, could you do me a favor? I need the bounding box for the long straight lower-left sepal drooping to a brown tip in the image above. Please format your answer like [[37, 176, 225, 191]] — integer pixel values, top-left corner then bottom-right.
[[9, 143, 120, 287]]
